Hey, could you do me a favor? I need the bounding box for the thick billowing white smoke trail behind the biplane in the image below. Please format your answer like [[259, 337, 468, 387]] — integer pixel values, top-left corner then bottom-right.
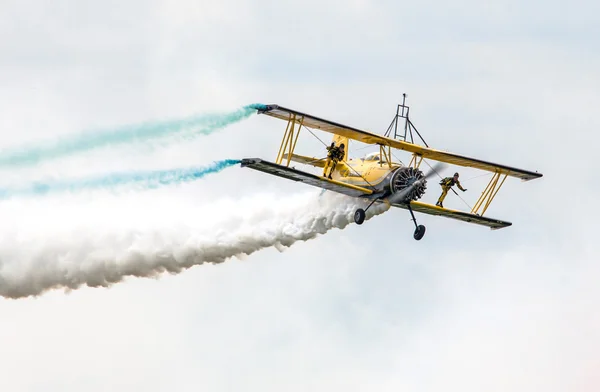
[[0, 192, 388, 298]]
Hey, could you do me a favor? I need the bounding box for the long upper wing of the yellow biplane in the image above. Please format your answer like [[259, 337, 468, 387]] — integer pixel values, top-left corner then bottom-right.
[[258, 105, 542, 180]]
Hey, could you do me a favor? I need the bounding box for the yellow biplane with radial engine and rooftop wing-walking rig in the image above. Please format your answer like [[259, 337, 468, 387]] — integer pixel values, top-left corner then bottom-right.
[[241, 95, 542, 240]]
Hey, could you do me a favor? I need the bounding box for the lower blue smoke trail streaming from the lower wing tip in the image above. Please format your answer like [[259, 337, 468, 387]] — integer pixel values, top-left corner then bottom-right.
[[0, 159, 241, 199]]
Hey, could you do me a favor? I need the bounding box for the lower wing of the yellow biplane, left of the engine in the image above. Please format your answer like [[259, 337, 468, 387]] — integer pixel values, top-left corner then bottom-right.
[[242, 158, 373, 197]]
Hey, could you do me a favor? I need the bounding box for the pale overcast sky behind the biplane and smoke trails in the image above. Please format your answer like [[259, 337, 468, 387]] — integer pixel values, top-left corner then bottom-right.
[[0, 0, 600, 392]]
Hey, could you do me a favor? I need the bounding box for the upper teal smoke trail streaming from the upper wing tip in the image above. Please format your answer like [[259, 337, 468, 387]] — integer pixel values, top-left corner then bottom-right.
[[0, 103, 266, 168]]
